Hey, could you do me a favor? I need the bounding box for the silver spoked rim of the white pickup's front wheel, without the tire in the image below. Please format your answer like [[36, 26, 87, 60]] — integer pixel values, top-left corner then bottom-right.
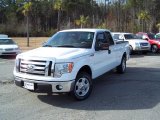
[[75, 78, 89, 96]]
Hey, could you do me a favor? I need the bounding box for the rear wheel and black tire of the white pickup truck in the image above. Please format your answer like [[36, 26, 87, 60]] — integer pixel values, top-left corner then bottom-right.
[[117, 56, 126, 74]]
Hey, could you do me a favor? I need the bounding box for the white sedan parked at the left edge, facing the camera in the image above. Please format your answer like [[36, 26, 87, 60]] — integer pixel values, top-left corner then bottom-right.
[[0, 34, 20, 56]]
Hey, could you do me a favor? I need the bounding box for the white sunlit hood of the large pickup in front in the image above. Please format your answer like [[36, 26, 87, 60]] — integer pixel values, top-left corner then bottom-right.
[[18, 47, 91, 59]]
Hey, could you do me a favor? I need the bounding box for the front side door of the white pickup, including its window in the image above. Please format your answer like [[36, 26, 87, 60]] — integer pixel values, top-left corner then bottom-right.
[[92, 32, 116, 78]]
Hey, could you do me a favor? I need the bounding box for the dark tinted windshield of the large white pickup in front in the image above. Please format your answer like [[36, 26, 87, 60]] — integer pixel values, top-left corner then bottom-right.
[[43, 31, 94, 48]]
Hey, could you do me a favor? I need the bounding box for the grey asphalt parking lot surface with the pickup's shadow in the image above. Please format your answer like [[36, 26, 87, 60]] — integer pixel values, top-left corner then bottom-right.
[[0, 54, 160, 120]]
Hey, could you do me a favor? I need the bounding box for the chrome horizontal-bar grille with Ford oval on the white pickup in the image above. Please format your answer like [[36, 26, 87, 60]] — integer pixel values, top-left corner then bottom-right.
[[20, 59, 52, 76]]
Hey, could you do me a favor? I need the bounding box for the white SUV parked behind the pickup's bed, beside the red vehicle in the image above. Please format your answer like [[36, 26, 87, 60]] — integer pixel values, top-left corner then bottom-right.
[[112, 32, 150, 54]]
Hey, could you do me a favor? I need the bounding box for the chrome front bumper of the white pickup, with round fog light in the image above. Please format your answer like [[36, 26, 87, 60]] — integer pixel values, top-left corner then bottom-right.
[[15, 77, 75, 93]]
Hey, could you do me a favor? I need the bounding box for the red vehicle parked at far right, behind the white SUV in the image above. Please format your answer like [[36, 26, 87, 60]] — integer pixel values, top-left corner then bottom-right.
[[136, 32, 160, 53]]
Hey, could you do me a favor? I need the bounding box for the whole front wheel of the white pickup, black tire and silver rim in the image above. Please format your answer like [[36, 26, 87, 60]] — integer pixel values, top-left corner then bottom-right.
[[72, 72, 92, 100]]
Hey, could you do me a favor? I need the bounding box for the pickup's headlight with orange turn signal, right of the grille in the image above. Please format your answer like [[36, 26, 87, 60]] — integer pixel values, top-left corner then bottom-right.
[[54, 63, 73, 77]]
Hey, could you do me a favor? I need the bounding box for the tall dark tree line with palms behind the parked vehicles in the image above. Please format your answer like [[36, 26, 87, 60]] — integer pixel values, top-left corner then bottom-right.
[[0, 0, 160, 36]]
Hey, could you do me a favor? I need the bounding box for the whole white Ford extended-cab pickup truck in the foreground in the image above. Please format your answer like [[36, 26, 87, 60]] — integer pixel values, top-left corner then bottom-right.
[[14, 29, 130, 100]]
